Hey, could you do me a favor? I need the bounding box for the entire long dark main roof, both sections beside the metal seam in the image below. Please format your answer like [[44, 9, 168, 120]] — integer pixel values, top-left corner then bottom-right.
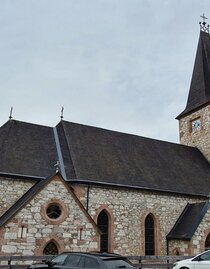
[[0, 120, 210, 196]]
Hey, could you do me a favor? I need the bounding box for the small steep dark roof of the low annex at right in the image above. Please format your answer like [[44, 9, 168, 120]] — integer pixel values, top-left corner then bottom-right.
[[166, 202, 209, 240]]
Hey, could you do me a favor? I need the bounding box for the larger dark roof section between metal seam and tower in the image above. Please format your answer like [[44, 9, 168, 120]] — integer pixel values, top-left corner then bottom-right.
[[57, 121, 210, 195]]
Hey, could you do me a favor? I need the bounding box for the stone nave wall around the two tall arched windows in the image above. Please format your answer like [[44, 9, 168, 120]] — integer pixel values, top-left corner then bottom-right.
[[73, 183, 205, 255]]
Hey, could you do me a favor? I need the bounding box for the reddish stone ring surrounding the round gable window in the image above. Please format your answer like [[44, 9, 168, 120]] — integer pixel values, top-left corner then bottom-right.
[[40, 199, 69, 225]]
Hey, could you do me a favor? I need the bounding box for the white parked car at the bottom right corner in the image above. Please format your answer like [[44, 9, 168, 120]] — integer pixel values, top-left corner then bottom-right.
[[173, 250, 210, 269]]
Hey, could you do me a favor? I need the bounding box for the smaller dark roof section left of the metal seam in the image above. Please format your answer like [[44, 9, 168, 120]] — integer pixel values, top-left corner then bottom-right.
[[0, 120, 58, 178]]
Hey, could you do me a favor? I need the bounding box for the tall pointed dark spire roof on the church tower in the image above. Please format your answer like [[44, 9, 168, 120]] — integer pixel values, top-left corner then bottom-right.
[[177, 31, 210, 119]]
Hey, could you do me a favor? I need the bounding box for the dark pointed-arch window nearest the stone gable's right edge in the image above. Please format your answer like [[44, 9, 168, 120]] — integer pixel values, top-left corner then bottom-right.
[[97, 210, 109, 252]]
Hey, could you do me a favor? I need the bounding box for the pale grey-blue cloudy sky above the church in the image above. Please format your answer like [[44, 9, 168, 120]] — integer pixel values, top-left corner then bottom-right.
[[0, 0, 210, 143]]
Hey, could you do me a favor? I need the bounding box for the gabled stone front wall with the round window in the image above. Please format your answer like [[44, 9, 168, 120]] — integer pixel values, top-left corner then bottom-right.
[[0, 175, 99, 255]]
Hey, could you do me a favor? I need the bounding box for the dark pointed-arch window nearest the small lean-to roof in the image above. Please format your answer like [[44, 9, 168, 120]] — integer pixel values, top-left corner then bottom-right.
[[145, 214, 155, 255]]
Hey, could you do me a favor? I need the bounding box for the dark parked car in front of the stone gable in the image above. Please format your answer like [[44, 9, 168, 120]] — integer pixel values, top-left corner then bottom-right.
[[27, 252, 135, 269]]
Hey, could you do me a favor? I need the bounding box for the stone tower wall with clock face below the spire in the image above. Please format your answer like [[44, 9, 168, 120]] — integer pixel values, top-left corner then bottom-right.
[[179, 105, 210, 162]]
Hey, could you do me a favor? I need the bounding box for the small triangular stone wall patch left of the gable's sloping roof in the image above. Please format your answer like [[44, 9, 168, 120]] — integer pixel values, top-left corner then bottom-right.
[[0, 177, 35, 216]]
